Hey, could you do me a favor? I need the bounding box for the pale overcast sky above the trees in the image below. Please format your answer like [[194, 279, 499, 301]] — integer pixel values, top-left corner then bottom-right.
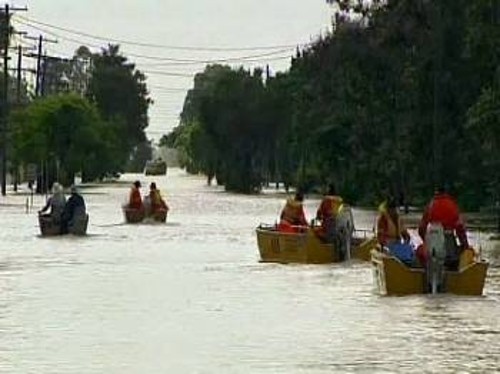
[[6, 0, 332, 141]]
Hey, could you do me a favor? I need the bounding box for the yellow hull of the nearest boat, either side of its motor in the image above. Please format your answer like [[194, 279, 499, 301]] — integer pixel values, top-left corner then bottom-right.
[[371, 250, 488, 296]]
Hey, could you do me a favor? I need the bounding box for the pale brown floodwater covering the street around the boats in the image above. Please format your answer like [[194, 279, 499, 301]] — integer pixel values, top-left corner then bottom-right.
[[0, 169, 500, 374]]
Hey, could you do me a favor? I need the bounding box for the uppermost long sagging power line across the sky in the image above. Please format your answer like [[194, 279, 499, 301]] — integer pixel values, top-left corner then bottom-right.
[[18, 16, 310, 52]]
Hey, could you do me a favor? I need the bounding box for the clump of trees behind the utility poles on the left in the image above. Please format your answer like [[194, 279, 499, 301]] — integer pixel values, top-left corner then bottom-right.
[[0, 39, 152, 192]]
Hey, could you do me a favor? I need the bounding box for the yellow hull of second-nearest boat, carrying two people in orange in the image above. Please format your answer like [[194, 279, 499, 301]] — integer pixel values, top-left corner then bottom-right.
[[256, 225, 376, 264]]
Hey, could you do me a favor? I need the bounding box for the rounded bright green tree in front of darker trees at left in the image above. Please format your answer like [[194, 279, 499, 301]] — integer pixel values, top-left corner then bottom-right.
[[11, 94, 116, 184]]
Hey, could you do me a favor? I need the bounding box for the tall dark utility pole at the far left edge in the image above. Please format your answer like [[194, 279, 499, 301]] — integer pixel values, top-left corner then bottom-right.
[[0, 4, 27, 196]]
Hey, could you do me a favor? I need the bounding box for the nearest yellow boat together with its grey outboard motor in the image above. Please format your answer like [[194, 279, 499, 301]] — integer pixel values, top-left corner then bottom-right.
[[371, 222, 488, 296]]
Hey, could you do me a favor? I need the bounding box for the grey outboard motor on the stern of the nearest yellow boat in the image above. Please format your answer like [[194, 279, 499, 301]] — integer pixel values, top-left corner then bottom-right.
[[425, 223, 446, 294]]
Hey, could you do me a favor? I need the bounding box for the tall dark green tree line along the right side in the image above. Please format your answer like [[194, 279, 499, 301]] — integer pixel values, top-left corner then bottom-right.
[[163, 0, 500, 209]]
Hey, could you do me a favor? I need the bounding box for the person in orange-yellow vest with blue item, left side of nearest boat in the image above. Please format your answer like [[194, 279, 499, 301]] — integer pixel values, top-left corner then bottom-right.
[[377, 197, 414, 265]]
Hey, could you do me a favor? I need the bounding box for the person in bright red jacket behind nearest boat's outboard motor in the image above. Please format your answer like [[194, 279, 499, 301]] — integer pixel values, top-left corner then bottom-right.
[[418, 185, 469, 270]]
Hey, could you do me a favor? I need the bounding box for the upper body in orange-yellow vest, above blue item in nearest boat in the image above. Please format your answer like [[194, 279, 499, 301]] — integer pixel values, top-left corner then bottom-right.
[[377, 198, 410, 247]]
